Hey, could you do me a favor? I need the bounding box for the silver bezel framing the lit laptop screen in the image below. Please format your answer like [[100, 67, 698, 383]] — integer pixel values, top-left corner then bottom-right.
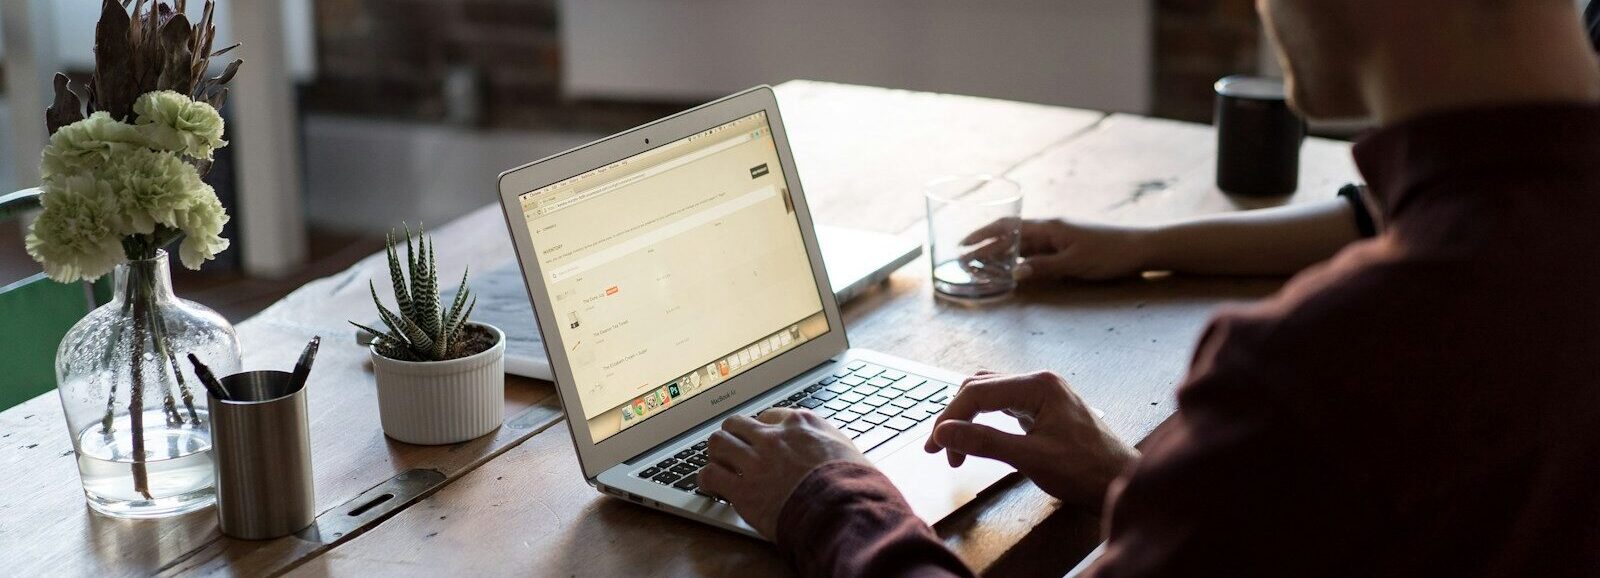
[[499, 85, 850, 480]]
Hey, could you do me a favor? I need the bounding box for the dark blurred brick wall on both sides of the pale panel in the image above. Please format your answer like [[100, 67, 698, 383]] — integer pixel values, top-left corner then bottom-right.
[[306, 0, 1259, 126]]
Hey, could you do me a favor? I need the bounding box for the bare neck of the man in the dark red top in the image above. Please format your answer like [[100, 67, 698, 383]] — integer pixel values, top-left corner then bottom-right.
[[1365, 5, 1600, 125]]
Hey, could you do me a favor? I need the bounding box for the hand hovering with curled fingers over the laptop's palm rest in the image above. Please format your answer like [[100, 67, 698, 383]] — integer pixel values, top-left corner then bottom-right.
[[923, 371, 1139, 511]]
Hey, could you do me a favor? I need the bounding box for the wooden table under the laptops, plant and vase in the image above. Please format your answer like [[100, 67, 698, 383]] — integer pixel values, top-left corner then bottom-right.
[[0, 82, 1357, 576]]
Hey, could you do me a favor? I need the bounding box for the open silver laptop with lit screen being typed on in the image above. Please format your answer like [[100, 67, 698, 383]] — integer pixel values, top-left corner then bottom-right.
[[499, 86, 1018, 535]]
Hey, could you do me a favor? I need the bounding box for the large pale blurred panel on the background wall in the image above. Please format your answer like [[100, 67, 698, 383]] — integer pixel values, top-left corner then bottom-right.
[[560, 0, 1152, 112]]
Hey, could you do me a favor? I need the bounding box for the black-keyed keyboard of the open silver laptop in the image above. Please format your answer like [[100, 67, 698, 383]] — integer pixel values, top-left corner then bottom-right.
[[634, 362, 952, 500]]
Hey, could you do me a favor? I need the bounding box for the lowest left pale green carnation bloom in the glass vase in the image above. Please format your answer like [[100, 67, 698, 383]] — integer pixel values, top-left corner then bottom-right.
[[26, 175, 126, 283]]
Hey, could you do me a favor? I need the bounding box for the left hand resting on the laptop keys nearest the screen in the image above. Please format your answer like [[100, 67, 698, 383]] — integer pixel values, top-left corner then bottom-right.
[[699, 408, 869, 538]]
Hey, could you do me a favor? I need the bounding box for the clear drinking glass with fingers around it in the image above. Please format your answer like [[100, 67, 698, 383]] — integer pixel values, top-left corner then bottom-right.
[[923, 175, 1022, 301]]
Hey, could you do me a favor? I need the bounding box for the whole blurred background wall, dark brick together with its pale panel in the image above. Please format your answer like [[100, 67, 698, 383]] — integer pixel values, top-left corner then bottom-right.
[[307, 0, 1261, 125]]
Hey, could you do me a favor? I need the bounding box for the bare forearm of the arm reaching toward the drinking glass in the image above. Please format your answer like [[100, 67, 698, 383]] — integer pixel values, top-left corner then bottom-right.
[[1144, 199, 1360, 275]]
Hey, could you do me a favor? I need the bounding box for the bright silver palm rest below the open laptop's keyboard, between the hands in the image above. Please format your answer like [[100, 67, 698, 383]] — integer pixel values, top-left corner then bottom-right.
[[875, 413, 1022, 525]]
